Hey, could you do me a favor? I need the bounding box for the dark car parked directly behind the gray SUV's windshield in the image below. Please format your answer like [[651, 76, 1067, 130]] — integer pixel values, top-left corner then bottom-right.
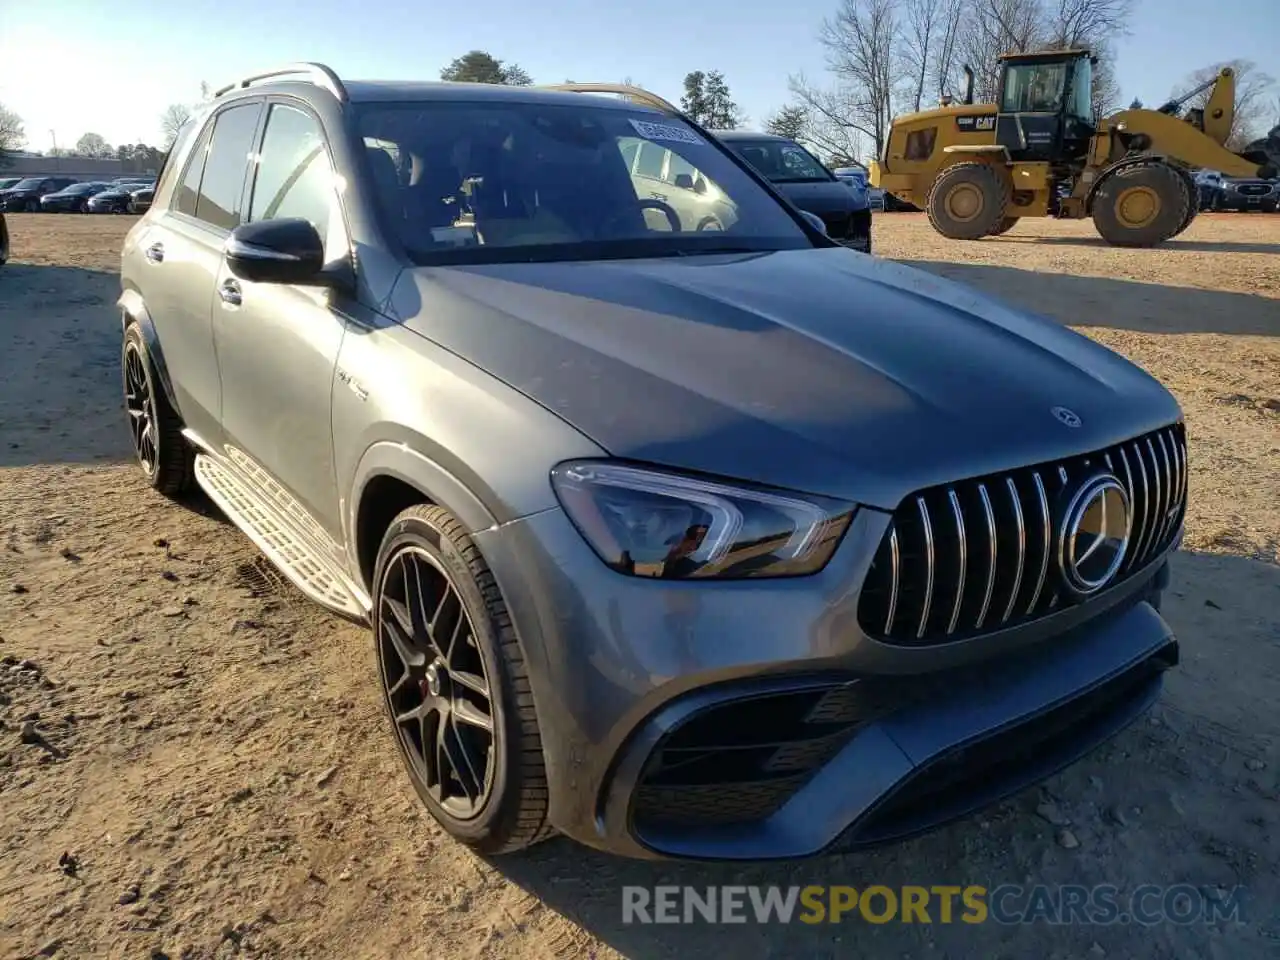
[[716, 131, 872, 253]]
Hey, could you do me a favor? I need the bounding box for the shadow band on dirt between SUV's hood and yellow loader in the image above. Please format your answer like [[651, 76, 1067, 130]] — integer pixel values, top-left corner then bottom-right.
[[897, 259, 1280, 337]]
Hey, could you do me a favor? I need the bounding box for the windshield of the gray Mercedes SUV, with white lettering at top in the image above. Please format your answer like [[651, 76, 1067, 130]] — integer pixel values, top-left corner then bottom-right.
[[358, 97, 812, 264]]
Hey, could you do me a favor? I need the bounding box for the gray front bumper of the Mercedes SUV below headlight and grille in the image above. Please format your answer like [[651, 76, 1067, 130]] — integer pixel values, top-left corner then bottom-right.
[[475, 509, 1176, 860]]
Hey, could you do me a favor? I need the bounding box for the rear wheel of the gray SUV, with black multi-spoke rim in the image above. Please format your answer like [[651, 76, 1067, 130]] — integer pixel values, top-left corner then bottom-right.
[[120, 324, 195, 497]]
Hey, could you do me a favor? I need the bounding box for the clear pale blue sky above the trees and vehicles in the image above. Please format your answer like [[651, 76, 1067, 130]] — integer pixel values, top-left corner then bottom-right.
[[0, 0, 1280, 150]]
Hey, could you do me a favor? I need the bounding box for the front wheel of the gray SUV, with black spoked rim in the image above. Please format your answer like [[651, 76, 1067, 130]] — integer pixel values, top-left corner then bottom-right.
[[371, 504, 552, 855]]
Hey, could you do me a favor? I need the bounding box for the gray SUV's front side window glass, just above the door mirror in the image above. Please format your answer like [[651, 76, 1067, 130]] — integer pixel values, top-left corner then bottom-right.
[[248, 104, 334, 237]]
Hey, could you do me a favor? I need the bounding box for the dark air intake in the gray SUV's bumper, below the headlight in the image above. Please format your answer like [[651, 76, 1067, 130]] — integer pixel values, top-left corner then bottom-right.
[[631, 682, 884, 833]]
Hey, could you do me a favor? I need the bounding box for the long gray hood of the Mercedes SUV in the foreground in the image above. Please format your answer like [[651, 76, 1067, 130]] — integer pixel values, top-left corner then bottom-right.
[[388, 248, 1180, 508]]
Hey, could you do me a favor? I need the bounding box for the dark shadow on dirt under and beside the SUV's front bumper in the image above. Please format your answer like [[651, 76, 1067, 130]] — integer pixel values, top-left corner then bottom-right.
[[492, 552, 1280, 959]]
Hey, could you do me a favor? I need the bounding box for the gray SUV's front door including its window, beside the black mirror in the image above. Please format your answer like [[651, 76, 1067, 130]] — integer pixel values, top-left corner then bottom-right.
[[214, 102, 348, 540]]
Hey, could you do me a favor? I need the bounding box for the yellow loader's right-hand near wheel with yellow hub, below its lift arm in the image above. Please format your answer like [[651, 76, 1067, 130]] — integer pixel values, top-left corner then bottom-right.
[[1093, 163, 1189, 247]]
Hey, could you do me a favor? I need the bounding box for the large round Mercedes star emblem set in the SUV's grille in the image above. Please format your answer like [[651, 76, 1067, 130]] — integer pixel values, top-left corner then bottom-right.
[[1057, 474, 1130, 596]]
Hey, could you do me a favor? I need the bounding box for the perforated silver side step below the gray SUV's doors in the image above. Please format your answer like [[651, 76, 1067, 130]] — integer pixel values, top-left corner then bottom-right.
[[196, 453, 369, 620]]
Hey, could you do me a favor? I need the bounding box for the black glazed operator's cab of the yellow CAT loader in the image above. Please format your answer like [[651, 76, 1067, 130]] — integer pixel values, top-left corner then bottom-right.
[[996, 50, 1096, 163]]
